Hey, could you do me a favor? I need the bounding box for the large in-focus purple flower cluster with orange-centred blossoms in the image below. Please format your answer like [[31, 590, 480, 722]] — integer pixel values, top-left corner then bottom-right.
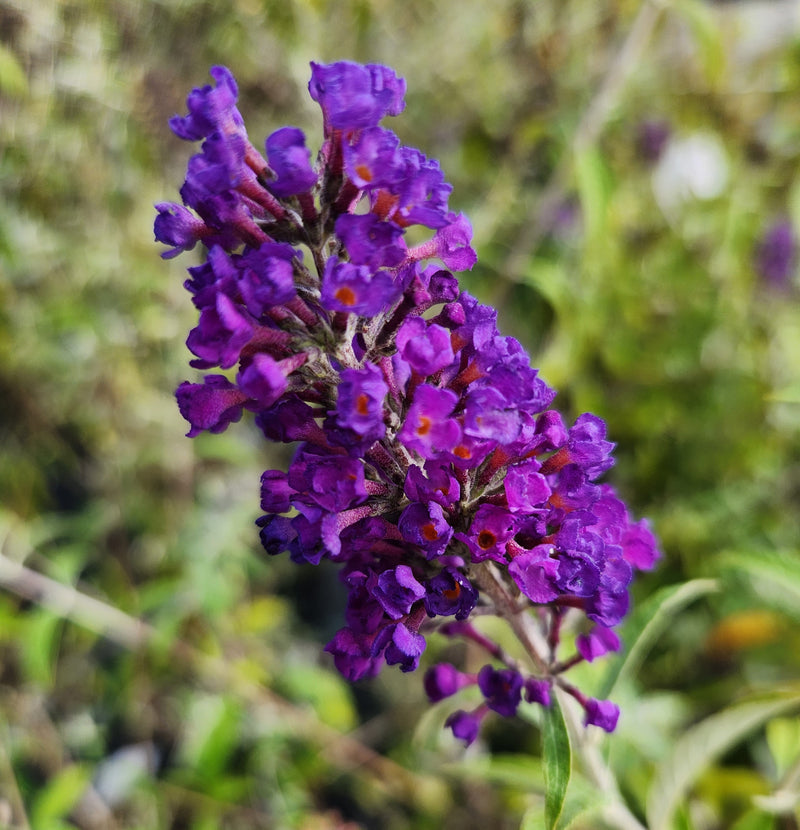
[[155, 62, 658, 743]]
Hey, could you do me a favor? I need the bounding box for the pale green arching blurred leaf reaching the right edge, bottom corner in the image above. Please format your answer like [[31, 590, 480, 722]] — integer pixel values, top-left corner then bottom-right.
[[647, 688, 800, 830]]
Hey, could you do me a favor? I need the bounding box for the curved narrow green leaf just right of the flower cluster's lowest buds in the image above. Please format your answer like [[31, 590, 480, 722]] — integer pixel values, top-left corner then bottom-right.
[[597, 579, 719, 699]]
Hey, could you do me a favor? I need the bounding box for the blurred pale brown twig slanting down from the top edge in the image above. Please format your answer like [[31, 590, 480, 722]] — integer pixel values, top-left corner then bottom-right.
[[504, 0, 668, 282]]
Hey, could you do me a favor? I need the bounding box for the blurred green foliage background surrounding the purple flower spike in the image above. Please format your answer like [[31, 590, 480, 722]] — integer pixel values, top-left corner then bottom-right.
[[0, 0, 800, 830]]
